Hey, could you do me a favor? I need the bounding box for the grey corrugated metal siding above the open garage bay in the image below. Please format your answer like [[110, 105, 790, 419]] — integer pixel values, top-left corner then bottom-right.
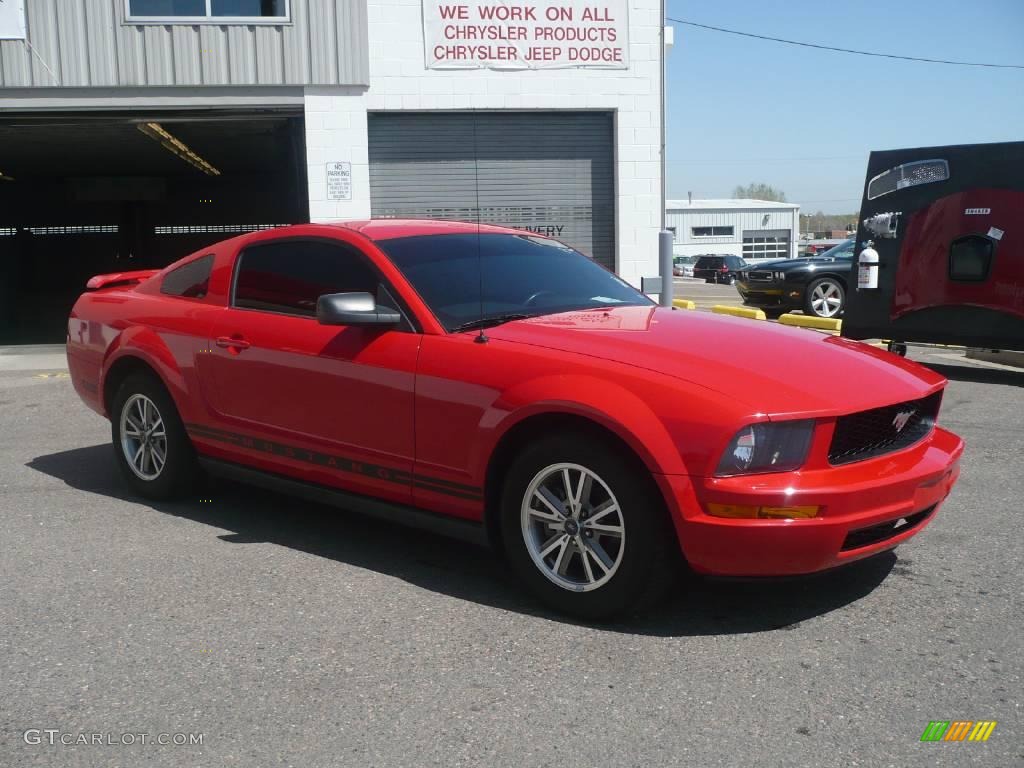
[[0, 0, 370, 88]]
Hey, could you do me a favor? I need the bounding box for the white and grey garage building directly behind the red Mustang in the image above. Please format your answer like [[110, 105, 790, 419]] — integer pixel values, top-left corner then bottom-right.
[[0, 0, 663, 343]]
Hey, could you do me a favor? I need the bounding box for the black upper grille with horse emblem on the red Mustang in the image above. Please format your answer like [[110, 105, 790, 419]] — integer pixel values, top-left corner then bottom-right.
[[828, 392, 942, 464]]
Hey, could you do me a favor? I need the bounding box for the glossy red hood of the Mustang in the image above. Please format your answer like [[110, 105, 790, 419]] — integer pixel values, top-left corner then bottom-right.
[[487, 306, 945, 418]]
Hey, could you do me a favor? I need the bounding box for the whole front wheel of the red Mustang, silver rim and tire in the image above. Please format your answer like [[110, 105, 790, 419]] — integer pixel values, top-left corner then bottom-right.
[[502, 435, 676, 618]]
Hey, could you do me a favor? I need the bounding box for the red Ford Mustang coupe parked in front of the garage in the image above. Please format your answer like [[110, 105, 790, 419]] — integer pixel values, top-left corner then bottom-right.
[[68, 220, 964, 617]]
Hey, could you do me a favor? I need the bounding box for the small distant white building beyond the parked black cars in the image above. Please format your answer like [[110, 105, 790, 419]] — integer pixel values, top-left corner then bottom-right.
[[666, 200, 800, 260]]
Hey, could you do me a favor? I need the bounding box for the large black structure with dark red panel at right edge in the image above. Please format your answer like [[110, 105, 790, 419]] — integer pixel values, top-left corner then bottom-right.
[[843, 142, 1024, 349]]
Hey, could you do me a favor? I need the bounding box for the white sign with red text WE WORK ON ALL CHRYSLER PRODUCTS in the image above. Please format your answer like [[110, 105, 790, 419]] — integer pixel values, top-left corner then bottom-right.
[[423, 0, 630, 70]]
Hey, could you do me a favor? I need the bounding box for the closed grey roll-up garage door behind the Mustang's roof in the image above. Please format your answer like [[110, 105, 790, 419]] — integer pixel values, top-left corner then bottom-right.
[[370, 113, 615, 268]]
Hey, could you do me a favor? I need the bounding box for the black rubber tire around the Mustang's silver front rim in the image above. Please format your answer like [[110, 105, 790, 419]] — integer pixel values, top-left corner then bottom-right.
[[501, 434, 681, 620]]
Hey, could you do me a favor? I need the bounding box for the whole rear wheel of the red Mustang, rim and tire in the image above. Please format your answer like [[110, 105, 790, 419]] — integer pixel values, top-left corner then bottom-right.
[[111, 373, 200, 500]]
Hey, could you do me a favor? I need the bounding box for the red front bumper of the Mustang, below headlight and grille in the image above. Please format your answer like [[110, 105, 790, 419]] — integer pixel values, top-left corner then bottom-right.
[[658, 428, 964, 577]]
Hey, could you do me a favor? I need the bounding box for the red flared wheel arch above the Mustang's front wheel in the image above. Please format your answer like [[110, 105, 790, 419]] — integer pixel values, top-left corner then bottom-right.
[[473, 375, 688, 480]]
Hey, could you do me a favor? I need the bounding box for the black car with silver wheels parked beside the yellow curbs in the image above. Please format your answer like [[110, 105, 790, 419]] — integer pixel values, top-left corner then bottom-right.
[[736, 238, 855, 317]]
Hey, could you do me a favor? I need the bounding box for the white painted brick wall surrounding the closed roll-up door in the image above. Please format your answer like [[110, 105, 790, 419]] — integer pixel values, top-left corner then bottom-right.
[[305, 0, 662, 286]]
